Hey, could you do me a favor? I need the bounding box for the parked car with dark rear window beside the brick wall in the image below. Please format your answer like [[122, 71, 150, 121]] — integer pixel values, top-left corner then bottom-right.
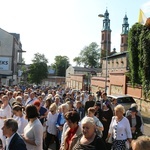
[[107, 94, 136, 111]]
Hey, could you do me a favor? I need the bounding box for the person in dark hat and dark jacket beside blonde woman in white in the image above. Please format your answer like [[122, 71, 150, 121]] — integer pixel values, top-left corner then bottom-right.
[[127, 107, 142, 139]]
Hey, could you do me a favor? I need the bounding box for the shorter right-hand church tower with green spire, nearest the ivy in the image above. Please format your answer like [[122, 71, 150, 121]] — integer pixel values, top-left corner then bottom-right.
[[120, 15, 129, 52]]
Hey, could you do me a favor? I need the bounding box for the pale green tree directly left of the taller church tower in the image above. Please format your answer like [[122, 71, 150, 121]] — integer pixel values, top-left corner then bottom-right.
[[73, 42, 100, 68]]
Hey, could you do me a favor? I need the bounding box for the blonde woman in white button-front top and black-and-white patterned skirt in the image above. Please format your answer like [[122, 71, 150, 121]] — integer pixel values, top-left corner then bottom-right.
[[106, 104, 132, 150]]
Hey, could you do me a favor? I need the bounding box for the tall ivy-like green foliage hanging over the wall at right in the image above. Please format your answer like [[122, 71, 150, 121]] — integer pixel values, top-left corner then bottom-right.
[[128, 23, 150, 98]]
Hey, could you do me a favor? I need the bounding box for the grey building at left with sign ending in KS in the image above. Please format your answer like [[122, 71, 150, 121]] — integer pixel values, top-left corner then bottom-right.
[[0, 28, 25, 86]]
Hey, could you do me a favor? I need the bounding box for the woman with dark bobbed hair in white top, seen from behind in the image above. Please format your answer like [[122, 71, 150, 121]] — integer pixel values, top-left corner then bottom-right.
[[22, 105, 43, 150]]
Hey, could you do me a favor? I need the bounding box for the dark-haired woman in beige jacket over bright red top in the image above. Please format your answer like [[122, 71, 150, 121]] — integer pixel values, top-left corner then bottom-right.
[[60, 111, 81, 150]]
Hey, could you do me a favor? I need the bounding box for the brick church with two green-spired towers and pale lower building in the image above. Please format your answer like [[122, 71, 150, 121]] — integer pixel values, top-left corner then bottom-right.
[[101, 10, 129, 76]]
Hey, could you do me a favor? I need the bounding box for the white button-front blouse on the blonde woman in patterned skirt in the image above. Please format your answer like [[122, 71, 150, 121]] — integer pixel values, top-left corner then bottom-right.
[[109, 116, 132, 140]]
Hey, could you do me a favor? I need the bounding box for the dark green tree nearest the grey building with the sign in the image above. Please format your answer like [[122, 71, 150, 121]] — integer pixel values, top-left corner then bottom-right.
[[28, 53, 48, 85]]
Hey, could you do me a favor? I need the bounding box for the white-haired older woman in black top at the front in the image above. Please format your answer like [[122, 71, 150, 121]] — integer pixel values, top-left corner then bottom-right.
[[74, 117, 106, 150]]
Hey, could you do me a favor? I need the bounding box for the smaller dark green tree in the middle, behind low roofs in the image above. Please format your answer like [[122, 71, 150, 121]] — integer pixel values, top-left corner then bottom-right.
[[51, 55, 70, 77]]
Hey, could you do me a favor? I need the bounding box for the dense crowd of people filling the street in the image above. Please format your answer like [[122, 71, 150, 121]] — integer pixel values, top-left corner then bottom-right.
[[0, 86, 150, 150]]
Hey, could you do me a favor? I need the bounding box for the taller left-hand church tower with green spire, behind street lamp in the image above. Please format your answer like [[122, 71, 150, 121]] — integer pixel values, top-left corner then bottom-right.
[[101, 9, 111, 57]]
